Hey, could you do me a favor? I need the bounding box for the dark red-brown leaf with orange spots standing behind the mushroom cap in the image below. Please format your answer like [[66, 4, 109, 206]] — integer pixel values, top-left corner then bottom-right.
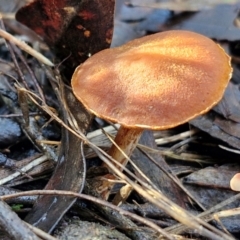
[[16, 0, 115, 73]]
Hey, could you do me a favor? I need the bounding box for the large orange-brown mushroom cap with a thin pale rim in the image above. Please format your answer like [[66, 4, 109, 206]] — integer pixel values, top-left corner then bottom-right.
[[72, 30, 232, 130]]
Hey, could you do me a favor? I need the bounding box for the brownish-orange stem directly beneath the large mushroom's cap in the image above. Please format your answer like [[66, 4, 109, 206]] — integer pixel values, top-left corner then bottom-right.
[[105, 126, 143, 169]]
